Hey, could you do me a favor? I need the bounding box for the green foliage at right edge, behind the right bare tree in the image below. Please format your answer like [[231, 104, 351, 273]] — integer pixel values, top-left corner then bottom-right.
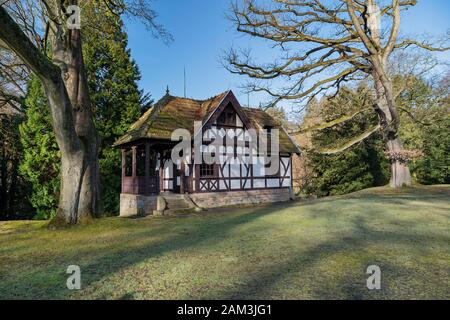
[[398, 74, 450, 184]]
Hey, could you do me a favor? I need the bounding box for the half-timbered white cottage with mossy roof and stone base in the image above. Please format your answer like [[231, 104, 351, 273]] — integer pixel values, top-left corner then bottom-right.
[[114, 90, 300, 216]]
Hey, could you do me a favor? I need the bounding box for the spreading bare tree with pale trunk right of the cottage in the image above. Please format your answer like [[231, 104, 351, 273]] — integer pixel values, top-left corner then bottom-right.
[[225, 0, 448, 188]]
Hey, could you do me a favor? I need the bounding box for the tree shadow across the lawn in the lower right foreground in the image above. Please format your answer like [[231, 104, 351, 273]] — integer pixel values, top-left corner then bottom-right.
[[214, 209, 450, 300]]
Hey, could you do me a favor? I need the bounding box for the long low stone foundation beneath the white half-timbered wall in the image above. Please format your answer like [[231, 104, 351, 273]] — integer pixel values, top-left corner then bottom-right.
[[189, 188, 290, 208]]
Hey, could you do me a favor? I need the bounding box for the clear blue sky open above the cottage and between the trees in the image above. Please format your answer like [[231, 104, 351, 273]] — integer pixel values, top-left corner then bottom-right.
[[126, 0, 450, 116]]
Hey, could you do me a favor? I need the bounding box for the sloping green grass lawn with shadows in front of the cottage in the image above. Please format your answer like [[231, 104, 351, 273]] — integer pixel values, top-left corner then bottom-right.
[[0, 186, 450, 299]]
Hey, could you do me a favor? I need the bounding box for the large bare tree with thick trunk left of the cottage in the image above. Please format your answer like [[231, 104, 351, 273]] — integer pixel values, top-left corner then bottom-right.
[[0, 0, 168, 224]]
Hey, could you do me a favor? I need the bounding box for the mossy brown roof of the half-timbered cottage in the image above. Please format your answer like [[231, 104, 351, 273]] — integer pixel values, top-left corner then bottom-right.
[[114, 91, 300, 153]]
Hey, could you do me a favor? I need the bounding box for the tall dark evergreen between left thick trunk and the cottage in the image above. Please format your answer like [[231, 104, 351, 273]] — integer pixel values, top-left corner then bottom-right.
[[84, 17, 149, 214]]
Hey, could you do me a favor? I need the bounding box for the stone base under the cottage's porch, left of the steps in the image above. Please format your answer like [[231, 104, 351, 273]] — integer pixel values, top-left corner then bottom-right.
[[120, 193, 157, 217]]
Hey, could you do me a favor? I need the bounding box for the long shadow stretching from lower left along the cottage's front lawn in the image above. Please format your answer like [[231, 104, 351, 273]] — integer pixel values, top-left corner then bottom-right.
[[0, 205, 296, 299]]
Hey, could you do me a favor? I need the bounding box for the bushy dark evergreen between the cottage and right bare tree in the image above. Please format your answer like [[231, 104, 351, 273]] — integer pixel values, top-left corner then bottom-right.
[[303, 85, 389, 197]]
